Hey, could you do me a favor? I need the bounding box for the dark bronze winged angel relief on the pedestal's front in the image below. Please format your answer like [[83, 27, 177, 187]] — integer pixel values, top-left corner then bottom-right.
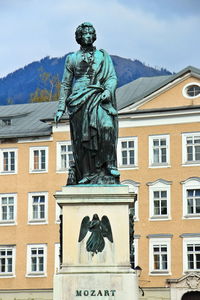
[[78, 214, 113, 255]]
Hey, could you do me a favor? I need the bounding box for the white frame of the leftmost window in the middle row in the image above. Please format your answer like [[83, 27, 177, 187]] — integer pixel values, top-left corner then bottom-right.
[[0, 194, 17, 226]]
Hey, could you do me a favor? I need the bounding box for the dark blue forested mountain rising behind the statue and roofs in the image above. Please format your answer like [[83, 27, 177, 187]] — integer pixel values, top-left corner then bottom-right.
[[0, 54, 171, 105]]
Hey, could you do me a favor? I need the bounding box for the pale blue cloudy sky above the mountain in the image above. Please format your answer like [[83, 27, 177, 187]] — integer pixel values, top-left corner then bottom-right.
[[0, 0, 200, 78]]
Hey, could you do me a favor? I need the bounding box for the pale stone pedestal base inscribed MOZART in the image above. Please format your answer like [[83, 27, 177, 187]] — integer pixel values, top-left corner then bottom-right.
[[53, 273, 138, 300]]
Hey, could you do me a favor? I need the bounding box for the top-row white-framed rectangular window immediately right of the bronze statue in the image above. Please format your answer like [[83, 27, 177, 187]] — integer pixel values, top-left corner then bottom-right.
[[118, 137, 138, 168]]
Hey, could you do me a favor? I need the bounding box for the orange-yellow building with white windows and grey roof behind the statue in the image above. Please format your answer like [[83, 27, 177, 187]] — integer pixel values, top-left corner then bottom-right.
[[0, 67, 200, 300]]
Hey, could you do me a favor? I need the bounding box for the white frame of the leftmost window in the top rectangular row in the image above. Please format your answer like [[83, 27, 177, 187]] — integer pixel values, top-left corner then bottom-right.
[[0, 148, 18, 175]]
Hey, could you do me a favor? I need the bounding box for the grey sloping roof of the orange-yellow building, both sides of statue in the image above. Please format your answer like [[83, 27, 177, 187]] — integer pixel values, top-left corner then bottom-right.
[[0, 66, 200, 139]]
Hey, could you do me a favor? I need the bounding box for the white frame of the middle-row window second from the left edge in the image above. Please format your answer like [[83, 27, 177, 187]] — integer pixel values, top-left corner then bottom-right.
[[28, 192, 48, 225]]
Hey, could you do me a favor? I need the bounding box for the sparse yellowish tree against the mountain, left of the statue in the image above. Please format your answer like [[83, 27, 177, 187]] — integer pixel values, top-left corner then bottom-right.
[[30, 68, 60, 103]]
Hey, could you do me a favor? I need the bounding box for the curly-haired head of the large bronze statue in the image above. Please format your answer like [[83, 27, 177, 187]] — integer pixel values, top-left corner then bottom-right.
[[75, 22, 97, 45]]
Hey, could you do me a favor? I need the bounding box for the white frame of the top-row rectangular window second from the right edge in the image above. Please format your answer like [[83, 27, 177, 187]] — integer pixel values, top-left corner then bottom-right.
[[149, 134, 170, 168]]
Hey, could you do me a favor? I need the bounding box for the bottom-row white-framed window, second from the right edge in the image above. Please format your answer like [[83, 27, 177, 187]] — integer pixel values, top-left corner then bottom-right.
[[149, 238, 171, 275]]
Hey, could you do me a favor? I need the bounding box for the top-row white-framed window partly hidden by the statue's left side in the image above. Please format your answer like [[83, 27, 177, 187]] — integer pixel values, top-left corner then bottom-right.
[[57, 142, 74, 172]]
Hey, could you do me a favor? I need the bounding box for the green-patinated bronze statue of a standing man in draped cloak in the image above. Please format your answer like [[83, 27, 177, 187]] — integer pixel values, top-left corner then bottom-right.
[[55, 22, 120, 184]]
